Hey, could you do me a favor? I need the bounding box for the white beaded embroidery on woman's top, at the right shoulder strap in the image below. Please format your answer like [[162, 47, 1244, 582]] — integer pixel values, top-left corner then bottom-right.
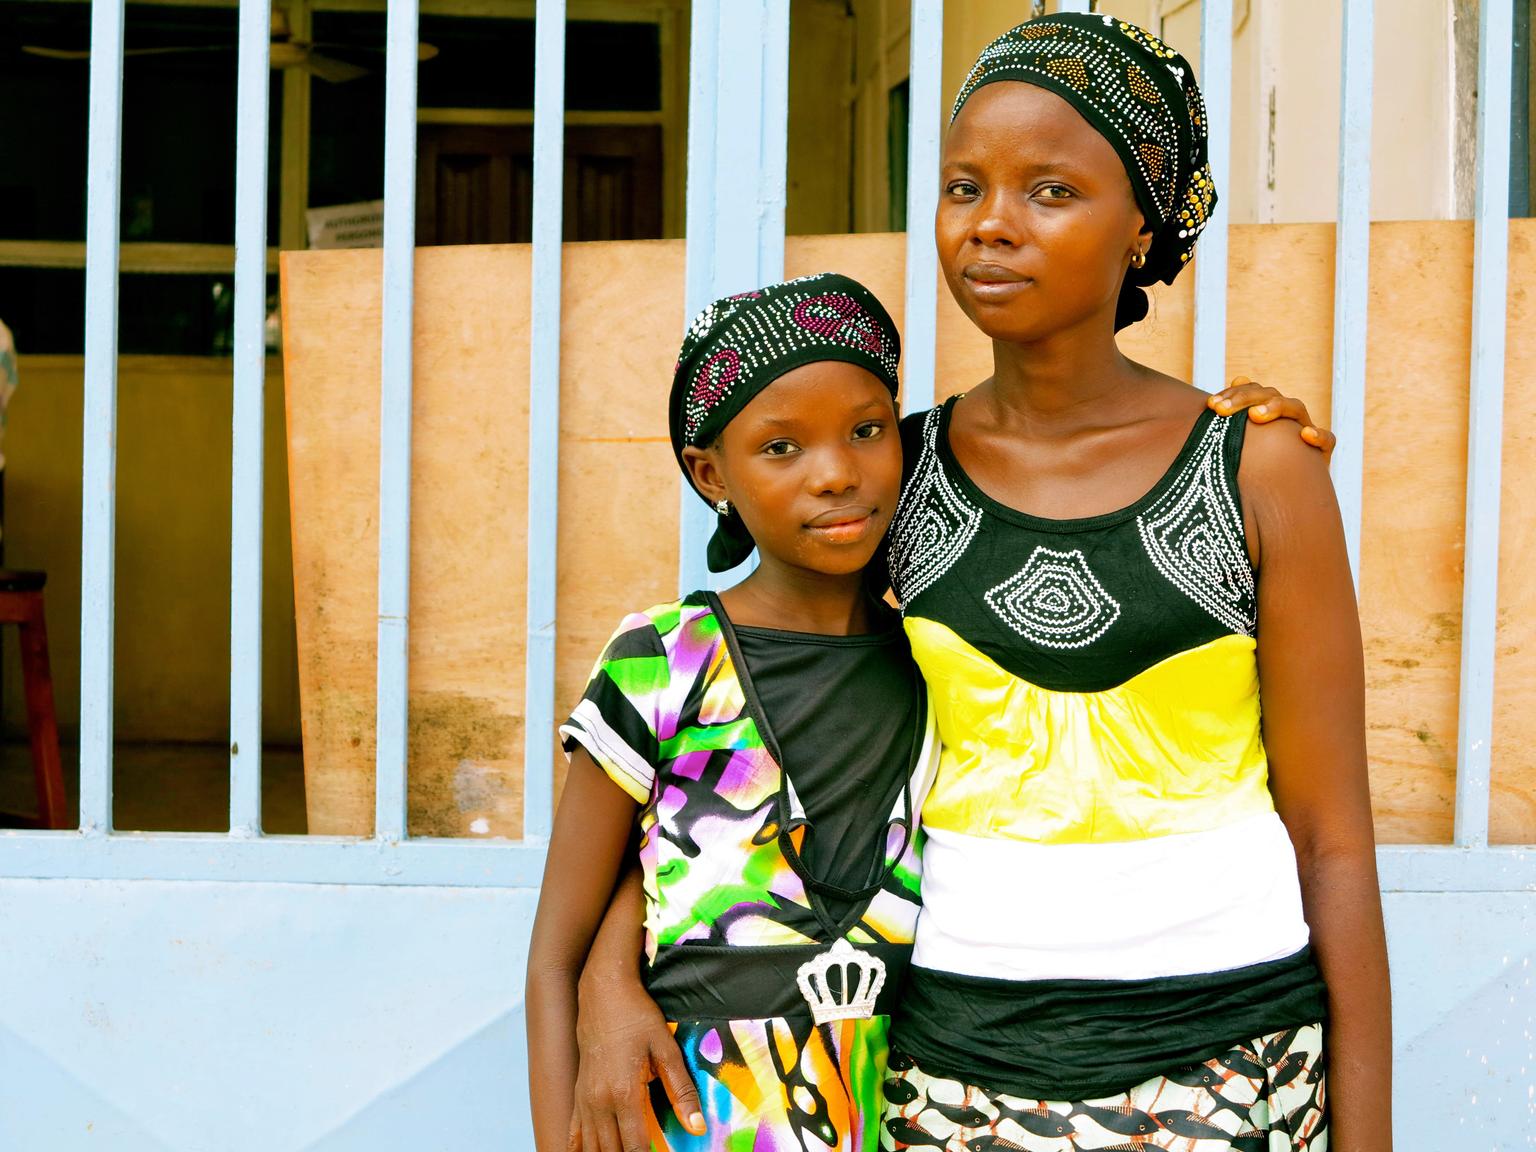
[[1137, 419, 1258, 636]]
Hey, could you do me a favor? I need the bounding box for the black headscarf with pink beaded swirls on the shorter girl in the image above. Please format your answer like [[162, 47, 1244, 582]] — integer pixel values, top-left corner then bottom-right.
[[668, 272, 902, 571]]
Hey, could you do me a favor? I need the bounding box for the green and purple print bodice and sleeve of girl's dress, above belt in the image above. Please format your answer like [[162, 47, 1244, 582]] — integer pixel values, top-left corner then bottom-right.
[[561, 596, 920, 960]]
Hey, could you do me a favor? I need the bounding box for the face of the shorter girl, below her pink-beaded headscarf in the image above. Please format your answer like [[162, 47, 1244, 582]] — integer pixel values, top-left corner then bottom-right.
[[684, 359, 902, 574]]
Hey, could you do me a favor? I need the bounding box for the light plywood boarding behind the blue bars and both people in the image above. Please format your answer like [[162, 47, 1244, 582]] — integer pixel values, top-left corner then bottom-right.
[[284, 221, 1536, 843]]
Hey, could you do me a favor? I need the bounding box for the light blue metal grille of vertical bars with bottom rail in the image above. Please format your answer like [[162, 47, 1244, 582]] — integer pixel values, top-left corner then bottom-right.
[[0, 0, 1536, 891]]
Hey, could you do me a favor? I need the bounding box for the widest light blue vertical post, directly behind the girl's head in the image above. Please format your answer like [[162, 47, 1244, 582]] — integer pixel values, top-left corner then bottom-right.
[[677, 0, 790, 590]]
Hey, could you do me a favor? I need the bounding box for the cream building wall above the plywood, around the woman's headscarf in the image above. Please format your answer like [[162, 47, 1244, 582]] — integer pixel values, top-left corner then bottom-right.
[[860, 0, 1467, 229]]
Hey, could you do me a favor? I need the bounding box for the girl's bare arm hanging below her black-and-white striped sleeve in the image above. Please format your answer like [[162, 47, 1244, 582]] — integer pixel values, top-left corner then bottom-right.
[[525, 746, 637, 1152]]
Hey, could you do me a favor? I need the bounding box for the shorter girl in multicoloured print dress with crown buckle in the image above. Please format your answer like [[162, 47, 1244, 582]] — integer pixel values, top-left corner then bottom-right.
[[527, 275, 937, 1152]]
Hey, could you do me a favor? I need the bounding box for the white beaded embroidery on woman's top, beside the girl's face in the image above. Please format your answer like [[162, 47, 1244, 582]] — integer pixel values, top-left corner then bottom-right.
[[889, 409, 982, 608]]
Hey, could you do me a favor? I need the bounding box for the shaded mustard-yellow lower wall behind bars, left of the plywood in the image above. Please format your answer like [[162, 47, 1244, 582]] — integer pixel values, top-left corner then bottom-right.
[[5, 355, 300, 743]]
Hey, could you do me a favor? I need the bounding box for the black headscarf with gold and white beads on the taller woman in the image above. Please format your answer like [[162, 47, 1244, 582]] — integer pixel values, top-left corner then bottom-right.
[[949, 12, 1217, 330]]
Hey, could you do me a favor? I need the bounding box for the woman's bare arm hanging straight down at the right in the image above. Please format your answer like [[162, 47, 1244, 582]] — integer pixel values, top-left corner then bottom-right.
[[1238, 427, 1392, 1152]]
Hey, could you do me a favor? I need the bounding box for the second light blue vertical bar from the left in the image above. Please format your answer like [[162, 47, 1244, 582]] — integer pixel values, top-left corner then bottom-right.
[[229, 0, 272, 836]]
